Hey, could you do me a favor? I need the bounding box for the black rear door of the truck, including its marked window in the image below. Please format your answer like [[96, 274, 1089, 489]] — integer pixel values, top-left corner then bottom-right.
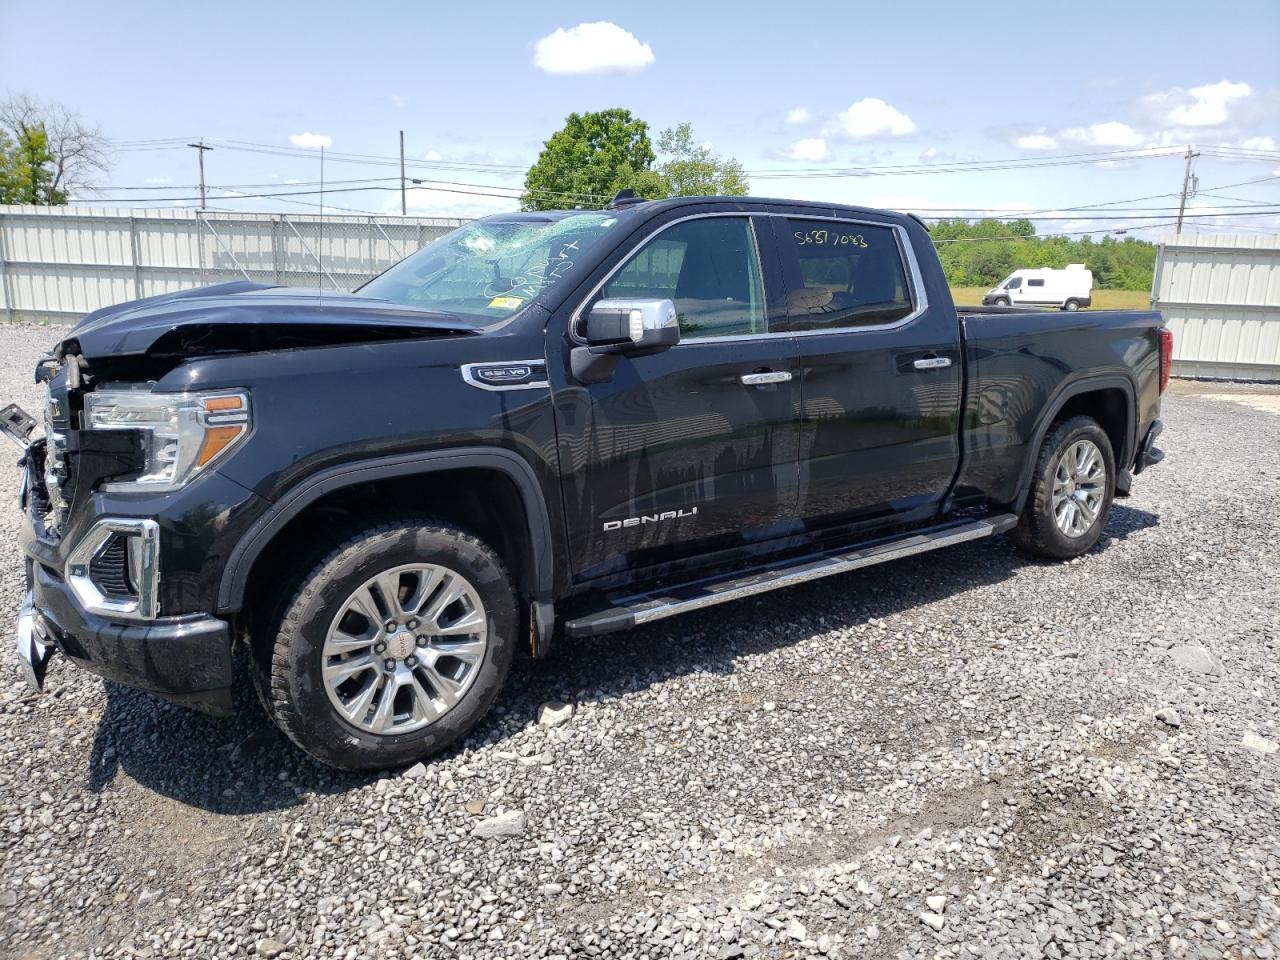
[[774, 215, 961, 526]]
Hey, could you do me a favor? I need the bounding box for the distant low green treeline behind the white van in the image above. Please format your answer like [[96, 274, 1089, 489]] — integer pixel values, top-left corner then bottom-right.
[[929, 220, 1156, 291]]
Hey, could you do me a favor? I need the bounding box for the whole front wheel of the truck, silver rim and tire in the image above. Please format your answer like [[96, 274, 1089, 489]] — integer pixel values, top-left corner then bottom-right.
[[259, 518, 518, 769]]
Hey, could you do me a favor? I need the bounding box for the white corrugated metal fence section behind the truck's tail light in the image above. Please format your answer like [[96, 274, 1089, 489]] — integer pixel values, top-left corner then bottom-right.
[[1151, 233, 1280, 380]]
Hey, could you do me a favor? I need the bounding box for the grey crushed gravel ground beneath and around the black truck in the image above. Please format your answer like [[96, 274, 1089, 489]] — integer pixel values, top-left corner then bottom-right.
[[0, 328, 1280, 960]]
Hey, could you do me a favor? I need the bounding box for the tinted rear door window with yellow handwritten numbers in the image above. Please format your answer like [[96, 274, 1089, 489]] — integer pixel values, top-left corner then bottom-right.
[[783, 218, 913, 330]]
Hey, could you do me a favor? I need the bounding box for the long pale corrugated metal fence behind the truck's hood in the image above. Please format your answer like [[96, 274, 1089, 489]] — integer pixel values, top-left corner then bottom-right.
[[0, 206, 465, 320]]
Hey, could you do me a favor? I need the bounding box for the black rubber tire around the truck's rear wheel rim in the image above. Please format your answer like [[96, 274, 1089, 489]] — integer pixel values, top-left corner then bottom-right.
[[1009, 416, 1116, 559]]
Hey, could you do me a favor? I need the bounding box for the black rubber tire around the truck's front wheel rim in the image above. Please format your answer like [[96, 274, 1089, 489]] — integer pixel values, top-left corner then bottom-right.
[[255, 517, 520, 769]]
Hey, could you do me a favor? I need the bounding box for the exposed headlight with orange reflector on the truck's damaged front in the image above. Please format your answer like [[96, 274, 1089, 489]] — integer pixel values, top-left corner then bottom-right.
[[84, 389, 251, 493]]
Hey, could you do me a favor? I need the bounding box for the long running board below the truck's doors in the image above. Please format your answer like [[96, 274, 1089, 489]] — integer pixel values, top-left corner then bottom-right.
[[564, 513, 1018, 636]]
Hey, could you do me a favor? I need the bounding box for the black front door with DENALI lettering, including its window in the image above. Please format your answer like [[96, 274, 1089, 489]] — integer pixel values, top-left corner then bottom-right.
[[549, 215, 800, 580]]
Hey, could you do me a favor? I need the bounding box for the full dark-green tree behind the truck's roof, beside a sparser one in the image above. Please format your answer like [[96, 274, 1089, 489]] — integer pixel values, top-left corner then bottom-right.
[[520, 108, 668, 210]]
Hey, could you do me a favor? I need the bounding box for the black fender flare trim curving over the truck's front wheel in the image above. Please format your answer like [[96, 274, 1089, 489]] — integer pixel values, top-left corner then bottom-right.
[[218, 447, 554, 613]]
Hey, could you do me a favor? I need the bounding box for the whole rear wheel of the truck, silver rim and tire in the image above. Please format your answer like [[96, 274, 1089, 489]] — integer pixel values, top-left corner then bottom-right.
[[1009, 416, 1116, 559]]
